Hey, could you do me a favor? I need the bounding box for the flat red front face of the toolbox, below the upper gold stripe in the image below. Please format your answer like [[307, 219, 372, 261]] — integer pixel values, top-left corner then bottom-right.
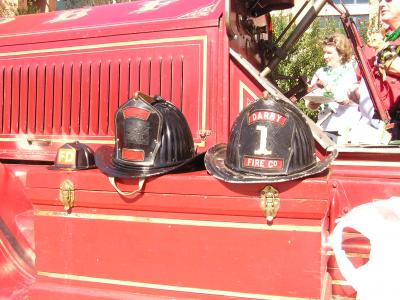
[[31, 206, 321, 299]]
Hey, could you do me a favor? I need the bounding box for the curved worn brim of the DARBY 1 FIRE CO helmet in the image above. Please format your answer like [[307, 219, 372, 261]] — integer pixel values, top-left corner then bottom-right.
[[204, 144, 337, 183]]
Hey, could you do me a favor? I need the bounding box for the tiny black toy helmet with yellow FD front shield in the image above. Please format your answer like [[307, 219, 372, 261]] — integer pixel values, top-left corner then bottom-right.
[[49, 141, 96, 170]]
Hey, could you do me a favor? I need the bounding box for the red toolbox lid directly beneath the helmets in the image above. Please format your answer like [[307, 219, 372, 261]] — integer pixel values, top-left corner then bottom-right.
[[26, 166, 331, 200]]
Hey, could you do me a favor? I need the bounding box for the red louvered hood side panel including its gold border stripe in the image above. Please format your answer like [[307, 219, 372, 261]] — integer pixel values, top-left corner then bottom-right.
[[0, 29, 217, 160]]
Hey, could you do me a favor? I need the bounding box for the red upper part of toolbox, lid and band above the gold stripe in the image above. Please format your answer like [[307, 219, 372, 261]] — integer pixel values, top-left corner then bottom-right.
[[26, 167, 329, 219]]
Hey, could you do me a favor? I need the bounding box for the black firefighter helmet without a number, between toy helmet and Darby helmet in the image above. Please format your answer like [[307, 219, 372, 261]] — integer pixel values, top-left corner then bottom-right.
[[95, 93, 204, 178]]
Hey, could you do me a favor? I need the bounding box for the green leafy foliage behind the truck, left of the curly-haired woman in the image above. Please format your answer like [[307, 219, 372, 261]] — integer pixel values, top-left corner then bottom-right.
[[272, 13, 368, 120]]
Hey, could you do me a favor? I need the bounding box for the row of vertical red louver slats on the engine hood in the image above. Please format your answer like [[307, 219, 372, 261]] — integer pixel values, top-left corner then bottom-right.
[[0, 51, 187, 136]]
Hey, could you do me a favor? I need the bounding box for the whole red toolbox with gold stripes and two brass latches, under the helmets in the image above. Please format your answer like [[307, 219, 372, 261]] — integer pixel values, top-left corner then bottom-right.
[[26, 167, 330, 299]]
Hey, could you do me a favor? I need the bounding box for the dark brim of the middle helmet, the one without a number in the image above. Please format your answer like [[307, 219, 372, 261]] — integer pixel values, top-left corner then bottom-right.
[[94, 146, 205, 178]]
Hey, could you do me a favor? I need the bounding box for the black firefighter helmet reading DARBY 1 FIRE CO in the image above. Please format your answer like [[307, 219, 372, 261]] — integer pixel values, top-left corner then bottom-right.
[[205, 98, 337, 183]]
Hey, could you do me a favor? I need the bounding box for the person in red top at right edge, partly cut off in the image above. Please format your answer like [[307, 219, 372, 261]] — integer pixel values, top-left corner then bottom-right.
[[349, 0, 400, 144]]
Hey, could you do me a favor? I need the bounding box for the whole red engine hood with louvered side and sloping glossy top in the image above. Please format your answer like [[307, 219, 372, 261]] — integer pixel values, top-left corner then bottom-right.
[[0, 0, 229, 161]]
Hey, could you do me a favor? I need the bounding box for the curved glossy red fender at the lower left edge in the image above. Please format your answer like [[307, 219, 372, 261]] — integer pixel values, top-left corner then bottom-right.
[[0, 164, 35, 300]]
